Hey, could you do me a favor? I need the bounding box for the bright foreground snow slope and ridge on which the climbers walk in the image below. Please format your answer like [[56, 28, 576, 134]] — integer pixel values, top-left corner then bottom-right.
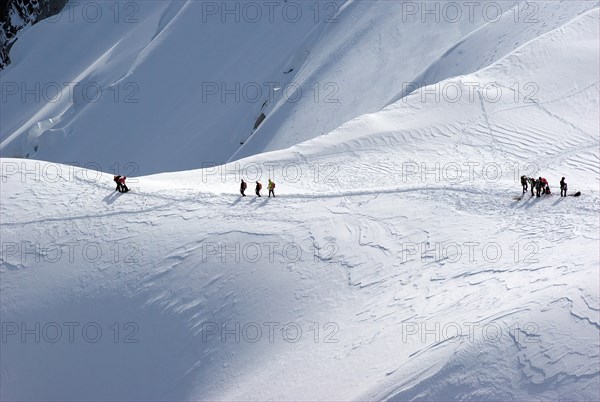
[[0, 4, 600, 400]]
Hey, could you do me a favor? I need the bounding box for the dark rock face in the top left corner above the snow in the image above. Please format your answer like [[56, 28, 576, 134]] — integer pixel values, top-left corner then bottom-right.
[[0, 0, 68, 70]]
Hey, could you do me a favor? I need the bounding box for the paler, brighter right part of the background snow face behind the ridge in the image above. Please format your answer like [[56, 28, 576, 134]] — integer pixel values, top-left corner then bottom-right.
[[234, 1, 598, 159]]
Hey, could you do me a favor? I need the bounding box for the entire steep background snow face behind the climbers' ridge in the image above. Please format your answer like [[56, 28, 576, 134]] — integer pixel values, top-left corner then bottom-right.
[[0, 0, 598, 174]]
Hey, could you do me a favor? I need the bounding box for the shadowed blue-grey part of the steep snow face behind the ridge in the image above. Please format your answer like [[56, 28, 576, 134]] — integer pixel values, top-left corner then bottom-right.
[[1, 1, 340, 173]]
